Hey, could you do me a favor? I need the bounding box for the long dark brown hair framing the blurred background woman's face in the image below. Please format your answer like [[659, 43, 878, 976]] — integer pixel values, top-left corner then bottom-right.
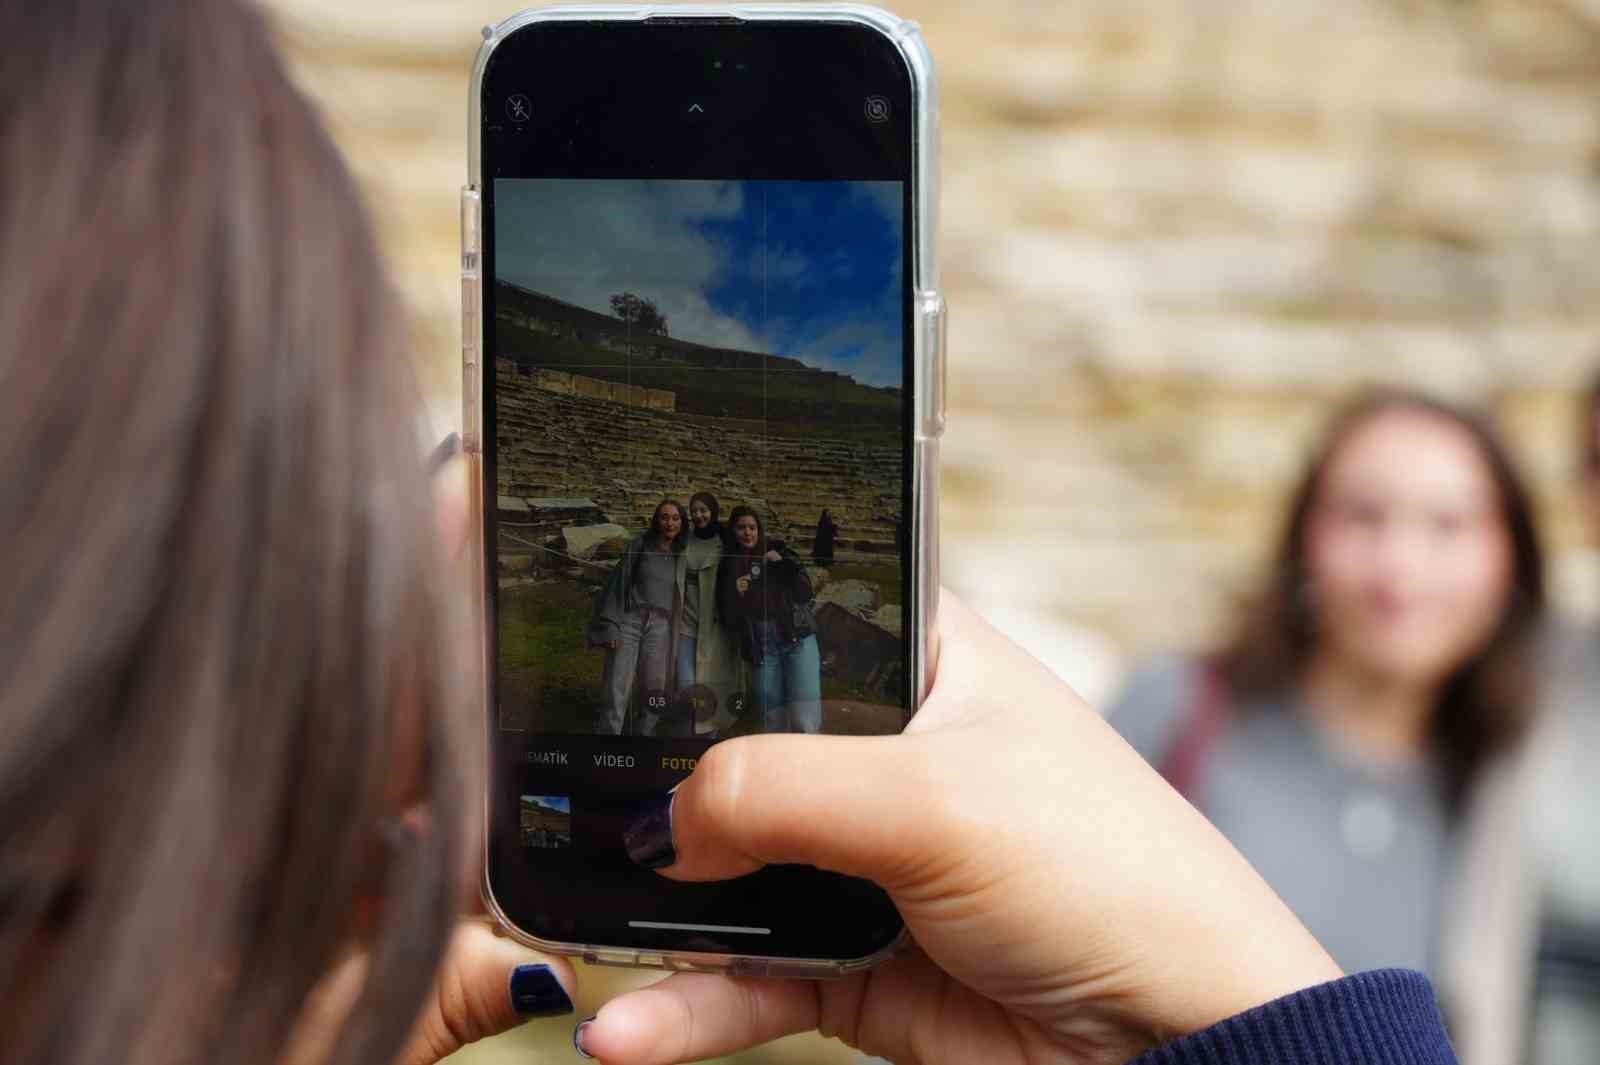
[[1219, 389, 1544, 806]]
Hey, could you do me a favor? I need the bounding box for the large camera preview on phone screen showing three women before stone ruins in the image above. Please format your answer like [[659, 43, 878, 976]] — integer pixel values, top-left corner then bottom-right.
[[491, 179, 910, 739]]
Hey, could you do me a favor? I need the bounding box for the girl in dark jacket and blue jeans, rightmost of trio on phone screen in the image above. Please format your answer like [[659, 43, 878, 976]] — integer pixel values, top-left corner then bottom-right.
[[717, 507, 822, 732]]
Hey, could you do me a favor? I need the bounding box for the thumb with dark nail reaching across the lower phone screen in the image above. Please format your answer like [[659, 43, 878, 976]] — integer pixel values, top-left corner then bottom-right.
[[624, 736, 947, 892]]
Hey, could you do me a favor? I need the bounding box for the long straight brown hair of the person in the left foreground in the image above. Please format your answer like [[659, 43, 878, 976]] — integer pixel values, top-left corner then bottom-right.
[[0, 0, 472, 1065]]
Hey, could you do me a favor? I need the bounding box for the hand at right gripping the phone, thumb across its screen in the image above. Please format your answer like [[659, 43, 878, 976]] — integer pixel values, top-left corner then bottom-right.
[[581, 593, 1342, 1065]]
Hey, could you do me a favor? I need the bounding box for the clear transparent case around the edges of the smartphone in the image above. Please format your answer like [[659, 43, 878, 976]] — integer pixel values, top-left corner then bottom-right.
[[461, 3, 946, 979]]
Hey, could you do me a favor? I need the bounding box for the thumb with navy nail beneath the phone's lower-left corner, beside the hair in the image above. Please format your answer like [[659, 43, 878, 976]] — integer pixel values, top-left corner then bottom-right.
[[398, 921, 576, 1065]]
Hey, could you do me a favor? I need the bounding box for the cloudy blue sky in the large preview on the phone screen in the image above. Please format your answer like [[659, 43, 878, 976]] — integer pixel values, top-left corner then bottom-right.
[[494, 179, 904, 385]]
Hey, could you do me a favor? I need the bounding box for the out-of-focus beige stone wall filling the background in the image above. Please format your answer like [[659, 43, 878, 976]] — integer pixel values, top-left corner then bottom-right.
[[256, 0, 1600, 1052]]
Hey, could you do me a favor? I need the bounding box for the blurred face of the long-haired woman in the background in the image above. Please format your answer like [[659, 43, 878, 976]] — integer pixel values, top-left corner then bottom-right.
[[1306, 411, 1514, 683]]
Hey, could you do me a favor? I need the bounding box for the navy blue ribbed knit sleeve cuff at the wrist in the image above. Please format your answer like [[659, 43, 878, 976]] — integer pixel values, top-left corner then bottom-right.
[[1130, 969, 1456, 1065]]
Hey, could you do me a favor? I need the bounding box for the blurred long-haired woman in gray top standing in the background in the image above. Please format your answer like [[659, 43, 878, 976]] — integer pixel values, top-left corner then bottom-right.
[[1110, 392, 1544, 972]]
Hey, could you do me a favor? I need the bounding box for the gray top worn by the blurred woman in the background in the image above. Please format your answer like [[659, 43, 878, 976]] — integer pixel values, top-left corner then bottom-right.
[[1107, 657, 1451, 972]]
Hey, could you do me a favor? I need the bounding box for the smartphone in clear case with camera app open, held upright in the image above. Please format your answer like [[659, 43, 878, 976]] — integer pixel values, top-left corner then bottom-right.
[[462, 5, 944, 977]]
